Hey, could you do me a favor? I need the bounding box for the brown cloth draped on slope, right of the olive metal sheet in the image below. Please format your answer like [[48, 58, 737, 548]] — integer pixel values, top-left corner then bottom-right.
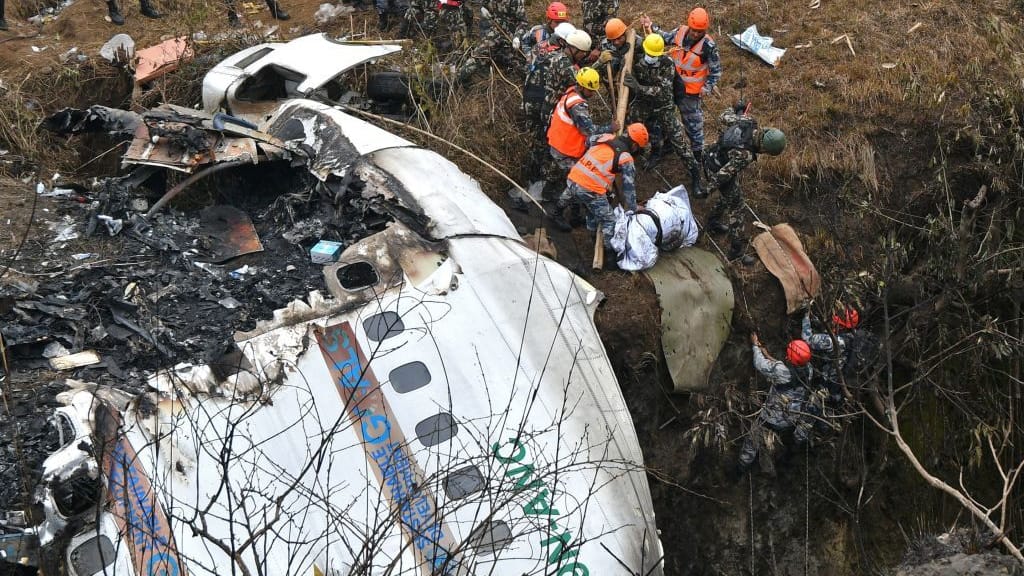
[[753, 223, 821, 314]]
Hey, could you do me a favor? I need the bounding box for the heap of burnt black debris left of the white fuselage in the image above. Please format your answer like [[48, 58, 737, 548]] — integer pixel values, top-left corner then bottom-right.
[[0, 157, 393, 510]]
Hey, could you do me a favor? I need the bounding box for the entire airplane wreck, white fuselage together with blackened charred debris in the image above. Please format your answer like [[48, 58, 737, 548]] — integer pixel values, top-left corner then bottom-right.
[[0, 34, 662, 576]]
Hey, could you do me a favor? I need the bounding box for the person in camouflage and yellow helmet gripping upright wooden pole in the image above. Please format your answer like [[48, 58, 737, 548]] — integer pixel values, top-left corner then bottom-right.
[[625, 34, 702, 197]]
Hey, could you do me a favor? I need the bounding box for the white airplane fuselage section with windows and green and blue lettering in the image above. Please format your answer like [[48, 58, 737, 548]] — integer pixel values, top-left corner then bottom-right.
[[40, 95, 662, 576]]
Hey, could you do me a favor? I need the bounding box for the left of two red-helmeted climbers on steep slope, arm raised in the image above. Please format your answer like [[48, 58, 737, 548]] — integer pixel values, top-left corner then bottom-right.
[[739, 333, 820, 471]]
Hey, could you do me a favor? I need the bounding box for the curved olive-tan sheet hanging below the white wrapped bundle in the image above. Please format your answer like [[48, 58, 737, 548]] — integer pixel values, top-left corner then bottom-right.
[[646, 248, 734, 392]]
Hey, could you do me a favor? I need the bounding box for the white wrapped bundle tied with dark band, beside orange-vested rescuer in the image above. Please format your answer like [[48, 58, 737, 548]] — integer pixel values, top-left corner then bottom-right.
[[610, 184, 697, 272]]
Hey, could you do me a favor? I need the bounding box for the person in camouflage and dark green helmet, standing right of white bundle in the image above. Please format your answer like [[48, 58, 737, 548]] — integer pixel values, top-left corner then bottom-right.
[[708, 102, 785, 265]]
